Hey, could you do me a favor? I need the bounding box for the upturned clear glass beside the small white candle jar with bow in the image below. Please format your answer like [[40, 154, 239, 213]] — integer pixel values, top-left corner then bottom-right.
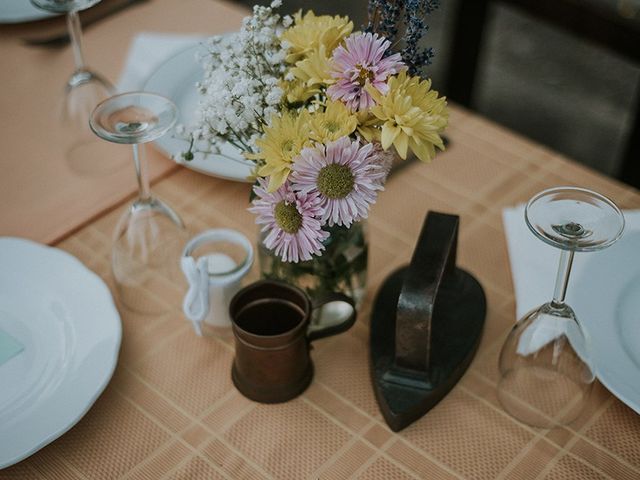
[[90, 92, 187, 314]]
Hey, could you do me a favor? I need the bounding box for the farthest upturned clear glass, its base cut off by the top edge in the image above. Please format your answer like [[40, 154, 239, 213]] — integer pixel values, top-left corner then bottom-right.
[[31, 0, 125, 174]]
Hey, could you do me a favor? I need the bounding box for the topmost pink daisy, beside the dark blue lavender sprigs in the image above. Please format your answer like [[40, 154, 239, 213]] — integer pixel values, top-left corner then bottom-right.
[[327, 33, 404, 111]]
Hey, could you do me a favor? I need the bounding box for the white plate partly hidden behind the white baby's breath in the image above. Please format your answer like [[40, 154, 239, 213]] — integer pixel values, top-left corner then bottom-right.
[[144, 44, 253, 182]]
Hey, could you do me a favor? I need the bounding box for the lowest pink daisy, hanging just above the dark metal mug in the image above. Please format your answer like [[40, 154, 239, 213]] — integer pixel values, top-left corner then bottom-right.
[[249, 178, 329, 263]]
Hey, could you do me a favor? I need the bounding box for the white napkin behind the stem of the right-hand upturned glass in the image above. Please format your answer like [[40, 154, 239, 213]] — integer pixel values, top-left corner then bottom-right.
[[502, 205, 640, 320]]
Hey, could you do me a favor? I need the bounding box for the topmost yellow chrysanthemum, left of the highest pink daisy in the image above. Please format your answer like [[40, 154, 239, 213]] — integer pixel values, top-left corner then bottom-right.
[[281, 10, 353, 63]]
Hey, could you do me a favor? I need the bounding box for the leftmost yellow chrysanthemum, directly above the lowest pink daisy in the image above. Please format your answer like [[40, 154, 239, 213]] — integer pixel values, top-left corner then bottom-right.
[[246, 110, 310, 192]]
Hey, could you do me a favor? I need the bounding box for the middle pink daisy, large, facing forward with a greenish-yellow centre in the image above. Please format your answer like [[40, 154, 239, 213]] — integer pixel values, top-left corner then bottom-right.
[[290, 137, 385, 227]]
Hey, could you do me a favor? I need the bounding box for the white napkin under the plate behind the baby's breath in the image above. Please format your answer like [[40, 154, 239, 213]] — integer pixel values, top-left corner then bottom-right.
[[118, 32, 206, 92]]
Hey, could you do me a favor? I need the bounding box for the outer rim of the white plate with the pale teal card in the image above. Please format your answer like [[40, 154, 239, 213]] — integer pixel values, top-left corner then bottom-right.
[[0, 237, 122, 469]]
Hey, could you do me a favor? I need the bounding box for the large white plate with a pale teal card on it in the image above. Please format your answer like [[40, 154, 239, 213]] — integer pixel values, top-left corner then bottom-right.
[[0, 237, 122, 468]]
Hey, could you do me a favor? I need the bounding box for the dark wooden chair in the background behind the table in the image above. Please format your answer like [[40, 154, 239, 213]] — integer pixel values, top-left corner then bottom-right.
[[446, 0, 640, 188]]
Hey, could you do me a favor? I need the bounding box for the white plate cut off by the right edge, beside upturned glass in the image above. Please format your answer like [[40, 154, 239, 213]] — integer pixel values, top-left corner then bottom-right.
[[569, 230, 640, 413]]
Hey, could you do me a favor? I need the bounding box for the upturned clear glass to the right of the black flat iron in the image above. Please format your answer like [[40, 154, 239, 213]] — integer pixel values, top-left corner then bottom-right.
[[498, 187, 624, 428]]
